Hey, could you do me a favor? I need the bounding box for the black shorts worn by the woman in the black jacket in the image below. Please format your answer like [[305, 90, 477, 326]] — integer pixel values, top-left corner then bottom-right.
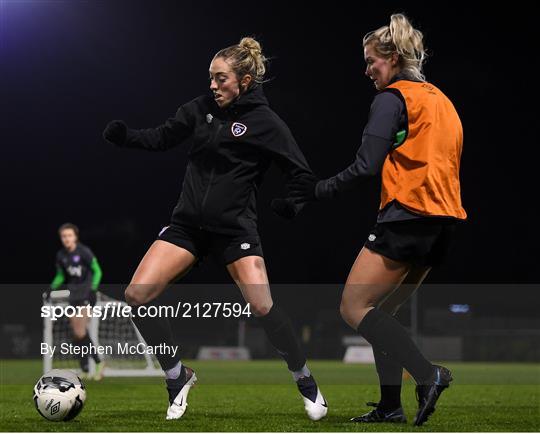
[[158, 225, 263, 265]]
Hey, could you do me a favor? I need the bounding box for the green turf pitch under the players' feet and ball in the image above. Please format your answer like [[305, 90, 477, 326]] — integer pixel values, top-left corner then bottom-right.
[[0, 360, 540, 432]]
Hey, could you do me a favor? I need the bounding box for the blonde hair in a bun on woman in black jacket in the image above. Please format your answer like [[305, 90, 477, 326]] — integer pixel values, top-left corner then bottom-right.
[[214, 37, 268, 88]]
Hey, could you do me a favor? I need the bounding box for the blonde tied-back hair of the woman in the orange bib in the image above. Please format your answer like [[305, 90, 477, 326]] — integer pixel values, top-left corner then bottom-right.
[[363, 14, 427, 81]]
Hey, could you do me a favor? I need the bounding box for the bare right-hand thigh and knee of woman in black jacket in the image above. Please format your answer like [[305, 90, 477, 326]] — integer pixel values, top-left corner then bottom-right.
[[227, 256, 273, 316]]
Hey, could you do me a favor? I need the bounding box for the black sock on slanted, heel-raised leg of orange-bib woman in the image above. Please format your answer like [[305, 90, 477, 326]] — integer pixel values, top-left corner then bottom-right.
[[358, 309, 434, 384]]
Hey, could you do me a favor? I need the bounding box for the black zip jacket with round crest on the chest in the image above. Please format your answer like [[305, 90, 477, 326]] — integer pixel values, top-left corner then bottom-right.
[[118, 86, 312, 235]]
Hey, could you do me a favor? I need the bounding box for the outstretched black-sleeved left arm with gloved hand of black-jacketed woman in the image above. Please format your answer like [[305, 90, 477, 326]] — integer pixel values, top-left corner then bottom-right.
[[103, 100, 197, 151]]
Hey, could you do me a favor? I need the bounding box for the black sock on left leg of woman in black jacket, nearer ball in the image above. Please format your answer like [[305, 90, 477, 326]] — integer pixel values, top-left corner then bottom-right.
[[131, 303, 180, 371]]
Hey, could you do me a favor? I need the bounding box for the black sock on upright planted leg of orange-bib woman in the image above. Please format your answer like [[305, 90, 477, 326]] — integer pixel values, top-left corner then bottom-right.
[[373, 348, 403, 411]]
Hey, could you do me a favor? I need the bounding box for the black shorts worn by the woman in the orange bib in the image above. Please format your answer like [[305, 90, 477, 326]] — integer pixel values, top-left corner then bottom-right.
[[365, 218, 457, 267]]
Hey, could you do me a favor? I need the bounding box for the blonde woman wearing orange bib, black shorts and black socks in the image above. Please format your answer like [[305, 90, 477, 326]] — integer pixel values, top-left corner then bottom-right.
[[291, 14, 466, 425]]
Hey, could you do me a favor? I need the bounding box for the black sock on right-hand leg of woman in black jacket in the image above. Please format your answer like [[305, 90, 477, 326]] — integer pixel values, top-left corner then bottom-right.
[[259, 304, 306, 371]]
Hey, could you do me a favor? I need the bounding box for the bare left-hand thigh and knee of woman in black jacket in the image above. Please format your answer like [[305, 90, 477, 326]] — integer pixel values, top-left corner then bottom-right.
[[125, 240, 197, 305]]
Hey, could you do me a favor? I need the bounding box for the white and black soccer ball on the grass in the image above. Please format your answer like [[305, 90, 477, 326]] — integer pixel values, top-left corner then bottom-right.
[[34, 369, 86, 422]]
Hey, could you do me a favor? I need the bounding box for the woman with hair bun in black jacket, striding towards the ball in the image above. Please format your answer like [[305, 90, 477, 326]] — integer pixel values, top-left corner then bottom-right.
[[104, 38, 327, 420]]
